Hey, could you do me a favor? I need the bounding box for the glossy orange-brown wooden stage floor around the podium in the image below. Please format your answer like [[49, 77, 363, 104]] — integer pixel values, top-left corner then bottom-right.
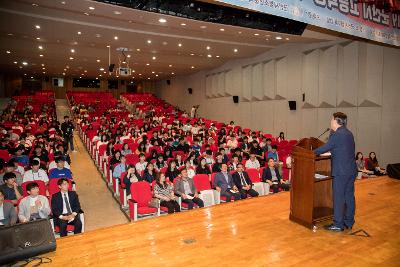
[[45, 177, 400, 266]]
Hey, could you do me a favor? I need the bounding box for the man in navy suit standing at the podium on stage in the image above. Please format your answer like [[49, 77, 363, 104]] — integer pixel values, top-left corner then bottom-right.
[[314, 112, 357, 232]]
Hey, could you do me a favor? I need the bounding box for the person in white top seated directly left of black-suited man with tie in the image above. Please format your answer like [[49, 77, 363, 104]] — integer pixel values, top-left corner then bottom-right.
[[18, 182, 51, 223]]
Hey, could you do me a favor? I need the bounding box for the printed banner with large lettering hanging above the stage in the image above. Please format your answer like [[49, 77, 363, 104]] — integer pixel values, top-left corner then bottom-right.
[[216, 0, 400, 46]]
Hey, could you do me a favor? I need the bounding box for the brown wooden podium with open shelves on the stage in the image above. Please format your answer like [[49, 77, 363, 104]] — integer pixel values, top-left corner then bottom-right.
[[289, 137, 333, 228]]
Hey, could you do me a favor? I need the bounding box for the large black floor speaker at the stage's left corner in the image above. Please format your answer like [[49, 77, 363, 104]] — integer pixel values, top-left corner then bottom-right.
[[0, 219, 56, 264]]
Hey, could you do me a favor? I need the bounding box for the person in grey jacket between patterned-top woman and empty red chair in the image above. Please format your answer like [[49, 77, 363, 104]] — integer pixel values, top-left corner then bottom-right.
[[175, 169, 204, 210]]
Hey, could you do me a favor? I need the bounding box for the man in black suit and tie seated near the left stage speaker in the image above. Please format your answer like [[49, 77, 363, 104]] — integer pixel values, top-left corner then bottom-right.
[[51, 178, 82, 237]]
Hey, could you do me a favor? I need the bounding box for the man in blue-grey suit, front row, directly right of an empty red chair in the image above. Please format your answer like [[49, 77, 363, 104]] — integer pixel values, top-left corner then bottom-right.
[[214, 163, 240, 202]]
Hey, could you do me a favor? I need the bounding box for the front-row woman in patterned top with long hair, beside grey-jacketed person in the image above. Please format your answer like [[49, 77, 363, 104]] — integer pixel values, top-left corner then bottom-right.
[[154, 173, 181, 213]]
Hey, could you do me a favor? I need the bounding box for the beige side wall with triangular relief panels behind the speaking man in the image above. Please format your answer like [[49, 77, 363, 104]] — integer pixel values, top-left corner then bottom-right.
[[155, 41, 400, 165]]
